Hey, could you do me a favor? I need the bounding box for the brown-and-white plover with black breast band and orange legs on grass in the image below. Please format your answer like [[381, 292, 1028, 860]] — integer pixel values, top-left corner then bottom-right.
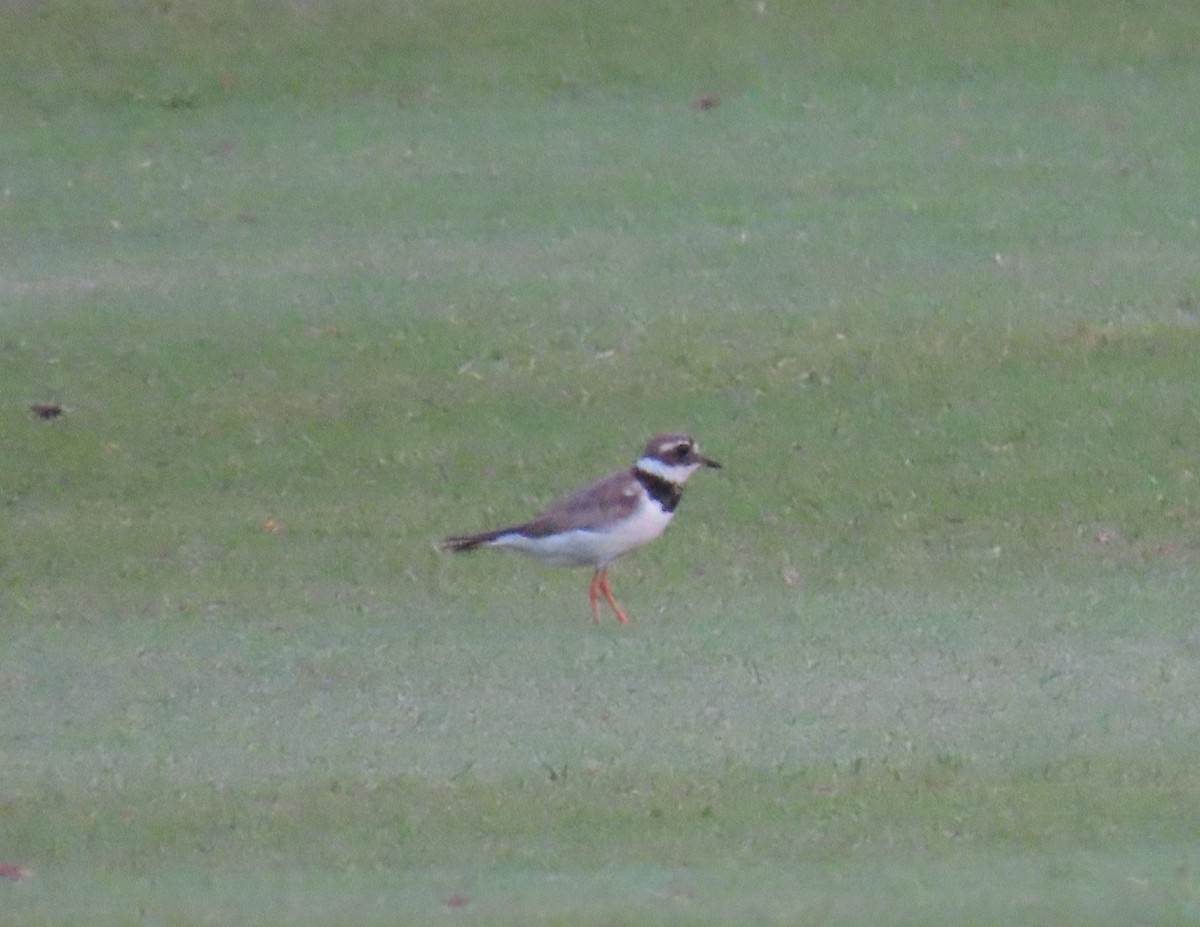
[[440, 433, 721, 624]]
